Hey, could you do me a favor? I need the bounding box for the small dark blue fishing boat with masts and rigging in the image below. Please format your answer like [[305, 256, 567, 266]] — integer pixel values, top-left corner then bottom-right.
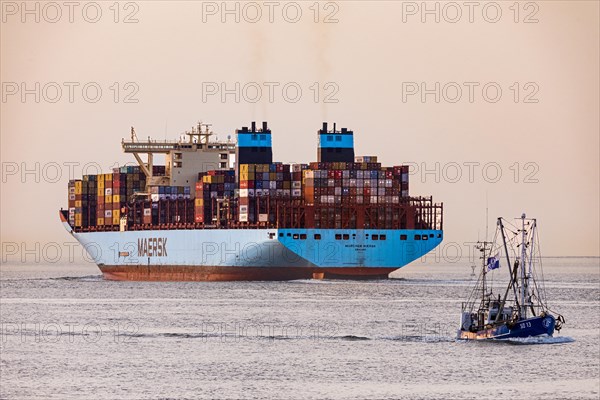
[[457, 214, 565, 340]]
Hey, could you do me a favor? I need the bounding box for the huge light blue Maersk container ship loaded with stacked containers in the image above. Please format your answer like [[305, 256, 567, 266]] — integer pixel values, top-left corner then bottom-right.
[[59, 122, 443, 281]]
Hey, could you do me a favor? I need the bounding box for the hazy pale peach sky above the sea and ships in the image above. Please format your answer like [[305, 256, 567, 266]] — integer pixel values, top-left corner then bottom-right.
[[0, 1, 600, 255]]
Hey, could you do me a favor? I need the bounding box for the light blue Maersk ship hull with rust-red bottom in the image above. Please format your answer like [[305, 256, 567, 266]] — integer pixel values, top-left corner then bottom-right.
[[63, 211, 443, 281]]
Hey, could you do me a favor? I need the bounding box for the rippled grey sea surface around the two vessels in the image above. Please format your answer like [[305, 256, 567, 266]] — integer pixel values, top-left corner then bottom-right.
[[0, 258, 600, 399]]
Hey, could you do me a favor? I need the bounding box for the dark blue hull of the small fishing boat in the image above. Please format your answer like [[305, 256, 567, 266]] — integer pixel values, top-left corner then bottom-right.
[[458, 314, 556, 340]]
